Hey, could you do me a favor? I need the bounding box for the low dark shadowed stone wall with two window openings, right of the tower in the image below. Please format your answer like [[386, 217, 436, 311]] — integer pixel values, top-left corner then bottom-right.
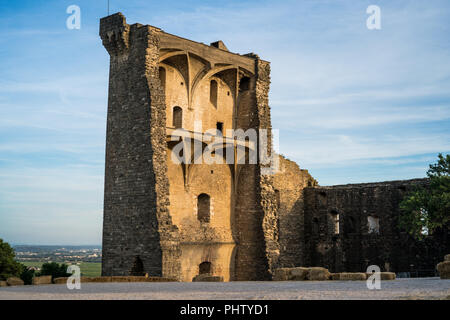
[[304, 179, 450, 276]]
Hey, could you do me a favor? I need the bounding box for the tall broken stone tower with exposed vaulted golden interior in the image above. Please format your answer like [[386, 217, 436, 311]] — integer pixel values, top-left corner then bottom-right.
[[100, 13, 279, 281]]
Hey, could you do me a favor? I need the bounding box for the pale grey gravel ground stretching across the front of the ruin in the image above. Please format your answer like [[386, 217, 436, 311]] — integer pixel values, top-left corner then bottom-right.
[[0, 278, 450, 300]]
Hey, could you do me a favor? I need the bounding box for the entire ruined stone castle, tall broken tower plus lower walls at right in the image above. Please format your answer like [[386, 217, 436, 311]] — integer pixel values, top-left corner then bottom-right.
[[100, 13, 448, 281]]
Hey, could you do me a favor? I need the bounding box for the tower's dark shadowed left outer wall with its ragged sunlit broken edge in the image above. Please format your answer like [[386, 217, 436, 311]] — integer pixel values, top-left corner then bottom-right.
[[100, 13, 179, 277]]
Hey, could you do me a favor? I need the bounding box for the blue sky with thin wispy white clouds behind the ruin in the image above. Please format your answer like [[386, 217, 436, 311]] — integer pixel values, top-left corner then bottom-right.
[[0, 0, 450, 244]]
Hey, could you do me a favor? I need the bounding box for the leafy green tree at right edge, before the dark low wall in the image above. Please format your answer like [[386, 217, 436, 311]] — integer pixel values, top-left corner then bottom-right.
[[400, 154, 450, 239]]
